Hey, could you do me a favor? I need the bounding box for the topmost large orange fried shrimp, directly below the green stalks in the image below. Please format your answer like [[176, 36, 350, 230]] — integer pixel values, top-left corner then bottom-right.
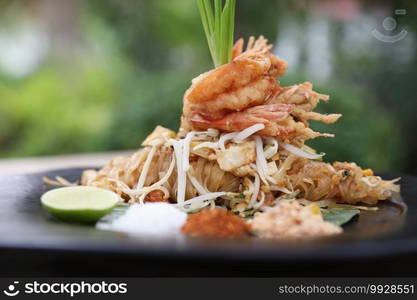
[[181, 36, 287, 134]]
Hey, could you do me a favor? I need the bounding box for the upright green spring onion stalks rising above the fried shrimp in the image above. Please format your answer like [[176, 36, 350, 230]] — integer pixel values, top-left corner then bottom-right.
[[197, 0, 236, 68]]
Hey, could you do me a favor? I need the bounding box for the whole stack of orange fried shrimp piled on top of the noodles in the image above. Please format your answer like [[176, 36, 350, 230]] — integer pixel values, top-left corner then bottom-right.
[[180, 36, 341, 141]]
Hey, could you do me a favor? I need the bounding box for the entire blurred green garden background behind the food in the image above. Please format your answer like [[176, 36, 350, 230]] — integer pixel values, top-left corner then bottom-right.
[[0, 0, 417, 173]]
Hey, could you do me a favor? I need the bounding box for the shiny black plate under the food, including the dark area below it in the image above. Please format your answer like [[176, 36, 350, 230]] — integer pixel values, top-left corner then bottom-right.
[[0, 169, 417, 276]]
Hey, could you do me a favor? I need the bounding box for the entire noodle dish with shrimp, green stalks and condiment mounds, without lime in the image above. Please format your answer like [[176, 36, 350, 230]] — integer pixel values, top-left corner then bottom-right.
[[40, 0, 399, 240]]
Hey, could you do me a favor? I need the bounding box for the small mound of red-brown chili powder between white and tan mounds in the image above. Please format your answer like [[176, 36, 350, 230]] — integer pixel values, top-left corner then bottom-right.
[[182, 208, 250, 238]]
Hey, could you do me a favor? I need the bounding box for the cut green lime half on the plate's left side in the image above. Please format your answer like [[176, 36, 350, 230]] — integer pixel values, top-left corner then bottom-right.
[[41, 186, 120, 223]]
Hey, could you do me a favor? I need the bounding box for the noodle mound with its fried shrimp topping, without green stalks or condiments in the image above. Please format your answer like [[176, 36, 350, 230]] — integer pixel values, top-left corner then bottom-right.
[[81, 36, 399, 219]]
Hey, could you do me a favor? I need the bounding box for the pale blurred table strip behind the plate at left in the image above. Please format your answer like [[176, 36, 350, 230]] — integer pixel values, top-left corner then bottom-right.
[[0, 151, 133, 175]]
